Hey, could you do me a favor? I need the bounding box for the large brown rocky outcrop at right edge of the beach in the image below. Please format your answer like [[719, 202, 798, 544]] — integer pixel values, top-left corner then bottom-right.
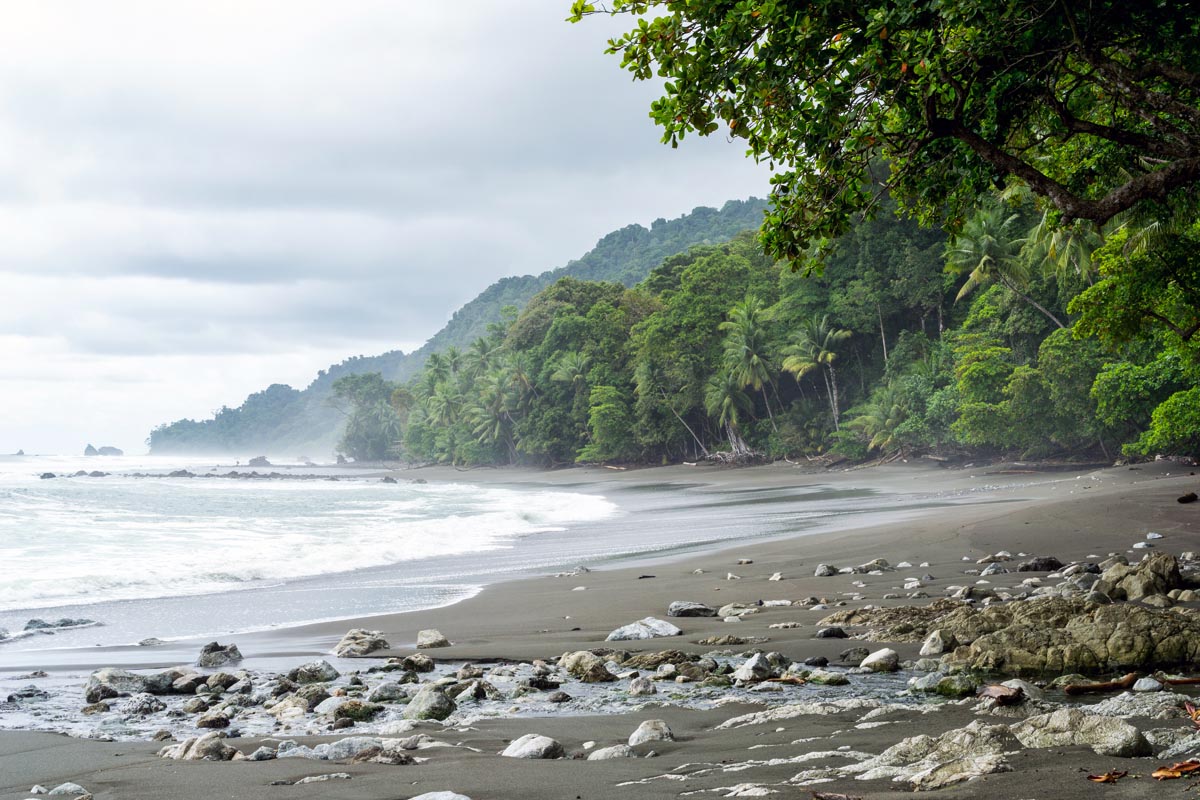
[[938, 597, 1200, 675]]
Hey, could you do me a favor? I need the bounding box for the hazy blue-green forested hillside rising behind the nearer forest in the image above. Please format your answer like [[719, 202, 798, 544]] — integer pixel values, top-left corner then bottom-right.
[[149, 198, 766, 457]]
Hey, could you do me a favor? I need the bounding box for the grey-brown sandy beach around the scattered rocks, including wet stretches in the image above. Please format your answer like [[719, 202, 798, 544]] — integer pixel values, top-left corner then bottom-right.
[[0, 462, 1200, 800]]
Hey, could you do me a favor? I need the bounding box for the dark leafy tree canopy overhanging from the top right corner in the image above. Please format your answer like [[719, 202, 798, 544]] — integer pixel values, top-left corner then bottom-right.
[[570, 0, 1200, 265]]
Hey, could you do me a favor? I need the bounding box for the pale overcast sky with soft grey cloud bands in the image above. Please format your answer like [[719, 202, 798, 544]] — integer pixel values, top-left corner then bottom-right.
[[0, 0, 768, 453]]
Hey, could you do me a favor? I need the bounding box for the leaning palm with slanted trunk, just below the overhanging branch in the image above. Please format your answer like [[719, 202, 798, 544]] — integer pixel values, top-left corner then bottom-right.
[[946, 203, 1066, 327]]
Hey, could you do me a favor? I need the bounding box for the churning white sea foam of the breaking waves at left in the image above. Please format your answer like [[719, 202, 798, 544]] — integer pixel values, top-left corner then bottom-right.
[[0, 461, 616, 610]]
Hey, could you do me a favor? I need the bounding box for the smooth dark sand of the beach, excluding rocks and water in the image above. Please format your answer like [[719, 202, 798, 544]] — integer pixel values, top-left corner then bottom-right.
[[0, 463, 1200, 800]]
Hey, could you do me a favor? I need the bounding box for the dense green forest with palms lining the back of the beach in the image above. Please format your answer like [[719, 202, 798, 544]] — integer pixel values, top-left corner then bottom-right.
[[334, 191, 1200, 465]]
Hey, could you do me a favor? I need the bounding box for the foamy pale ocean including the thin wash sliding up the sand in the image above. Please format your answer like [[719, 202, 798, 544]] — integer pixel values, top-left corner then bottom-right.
[[0, 457, 926, 668]]
